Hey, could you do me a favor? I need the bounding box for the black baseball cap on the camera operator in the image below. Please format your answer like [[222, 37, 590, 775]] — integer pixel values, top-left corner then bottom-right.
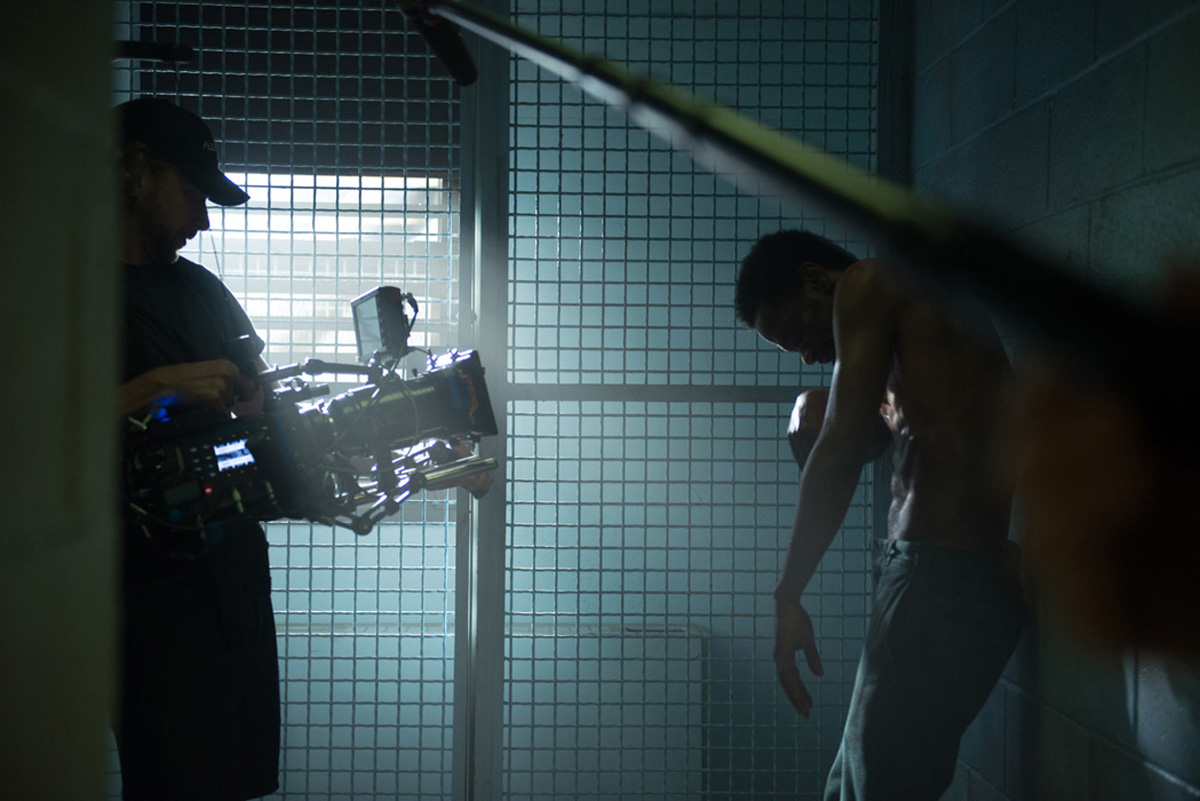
[[116, 97, 250, 206]]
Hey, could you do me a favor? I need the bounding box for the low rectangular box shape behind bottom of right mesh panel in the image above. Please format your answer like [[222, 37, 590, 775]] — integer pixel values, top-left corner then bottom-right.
[[505, 622, 707, 801]]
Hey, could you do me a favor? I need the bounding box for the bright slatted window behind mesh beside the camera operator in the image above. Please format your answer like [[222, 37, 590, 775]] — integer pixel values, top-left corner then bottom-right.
[[181, 173, 457, 365]]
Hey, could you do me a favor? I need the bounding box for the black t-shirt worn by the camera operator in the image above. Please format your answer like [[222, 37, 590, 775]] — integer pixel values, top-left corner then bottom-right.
[[121, 258, 266, 585]]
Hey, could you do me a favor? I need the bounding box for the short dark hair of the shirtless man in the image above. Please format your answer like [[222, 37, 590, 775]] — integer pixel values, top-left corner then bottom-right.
[[733, 229, 858, 329]]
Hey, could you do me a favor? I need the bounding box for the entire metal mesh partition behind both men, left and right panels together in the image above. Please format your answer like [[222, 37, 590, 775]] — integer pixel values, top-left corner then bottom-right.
[[113, 0, 875, 799]]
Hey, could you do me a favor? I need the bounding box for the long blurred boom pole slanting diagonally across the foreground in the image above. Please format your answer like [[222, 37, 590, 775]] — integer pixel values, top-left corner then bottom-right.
[[426, 0, 1200, 451]]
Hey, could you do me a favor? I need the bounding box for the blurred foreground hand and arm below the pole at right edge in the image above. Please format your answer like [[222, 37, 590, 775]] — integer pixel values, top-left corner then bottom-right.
[[1015, 265, 1200, 663]]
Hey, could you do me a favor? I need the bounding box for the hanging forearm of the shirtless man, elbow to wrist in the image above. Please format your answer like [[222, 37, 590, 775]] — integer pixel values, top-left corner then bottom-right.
[[775, 442, 862, 601]]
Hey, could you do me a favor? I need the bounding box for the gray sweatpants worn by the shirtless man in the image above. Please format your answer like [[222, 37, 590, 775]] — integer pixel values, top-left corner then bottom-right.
[[824, 540, 1024, 801]]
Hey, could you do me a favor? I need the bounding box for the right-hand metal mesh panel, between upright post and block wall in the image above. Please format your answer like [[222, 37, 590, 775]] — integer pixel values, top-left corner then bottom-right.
[[503, 0, 876, 800]]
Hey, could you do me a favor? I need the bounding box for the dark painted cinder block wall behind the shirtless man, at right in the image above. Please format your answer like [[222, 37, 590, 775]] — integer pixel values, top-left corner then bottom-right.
[[913, 0, 1200, 801]]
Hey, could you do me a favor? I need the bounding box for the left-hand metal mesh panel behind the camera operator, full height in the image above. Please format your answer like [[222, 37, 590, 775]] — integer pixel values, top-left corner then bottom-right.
[[112, 0, 461, 799]]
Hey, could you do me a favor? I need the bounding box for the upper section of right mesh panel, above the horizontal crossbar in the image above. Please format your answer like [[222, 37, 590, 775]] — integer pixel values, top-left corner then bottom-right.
[[509, 0, 876, 386]]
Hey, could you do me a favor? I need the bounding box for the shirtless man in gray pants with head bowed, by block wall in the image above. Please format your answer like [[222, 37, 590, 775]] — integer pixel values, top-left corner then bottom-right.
[[734, 231, 1022, 801]]
